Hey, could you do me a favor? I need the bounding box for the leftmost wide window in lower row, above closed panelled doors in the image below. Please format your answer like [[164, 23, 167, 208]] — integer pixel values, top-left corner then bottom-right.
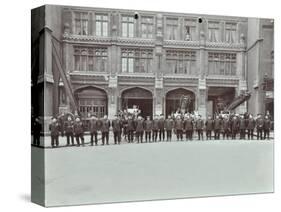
[[74, 47, 107, 72]]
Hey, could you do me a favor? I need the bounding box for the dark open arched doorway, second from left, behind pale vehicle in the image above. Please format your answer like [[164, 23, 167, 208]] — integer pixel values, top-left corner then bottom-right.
[[121, 87, 153, 117]]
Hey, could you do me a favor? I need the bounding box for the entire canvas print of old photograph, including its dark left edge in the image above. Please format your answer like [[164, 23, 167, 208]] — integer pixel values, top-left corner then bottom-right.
[[31, 5, 274, 207]]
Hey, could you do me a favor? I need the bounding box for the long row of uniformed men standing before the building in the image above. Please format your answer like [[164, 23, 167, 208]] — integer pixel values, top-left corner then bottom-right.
[[30, 114, 271, 147]]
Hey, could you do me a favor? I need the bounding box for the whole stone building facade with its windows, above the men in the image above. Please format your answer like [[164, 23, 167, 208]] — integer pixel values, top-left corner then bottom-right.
[[33, 5, 273, 125]]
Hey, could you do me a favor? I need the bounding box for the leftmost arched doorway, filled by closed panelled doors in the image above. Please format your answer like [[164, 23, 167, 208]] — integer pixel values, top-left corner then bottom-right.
[[75, 86, 107, 118]]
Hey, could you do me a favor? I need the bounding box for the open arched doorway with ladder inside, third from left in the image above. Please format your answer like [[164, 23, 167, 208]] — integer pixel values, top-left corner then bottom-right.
[[166, 88, 195, 115]]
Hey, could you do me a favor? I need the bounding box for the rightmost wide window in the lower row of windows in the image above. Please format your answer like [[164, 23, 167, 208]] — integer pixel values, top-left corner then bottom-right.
[[208, 52, 236, 75]]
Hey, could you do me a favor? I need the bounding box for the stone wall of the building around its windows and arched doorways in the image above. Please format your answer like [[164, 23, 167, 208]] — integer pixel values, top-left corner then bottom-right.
[[35, 6, 274, 121]]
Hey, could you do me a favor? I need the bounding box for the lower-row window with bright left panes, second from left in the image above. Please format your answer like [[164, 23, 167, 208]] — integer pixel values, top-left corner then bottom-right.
[[121, 49, 152, 73]]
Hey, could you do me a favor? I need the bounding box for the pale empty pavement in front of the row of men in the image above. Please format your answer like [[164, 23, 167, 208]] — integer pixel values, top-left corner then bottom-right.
[[32, 136, 274, 206]]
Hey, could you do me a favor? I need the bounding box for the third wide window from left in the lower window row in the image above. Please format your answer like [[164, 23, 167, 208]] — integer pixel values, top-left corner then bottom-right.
[[166, 50, 196, 75]]
